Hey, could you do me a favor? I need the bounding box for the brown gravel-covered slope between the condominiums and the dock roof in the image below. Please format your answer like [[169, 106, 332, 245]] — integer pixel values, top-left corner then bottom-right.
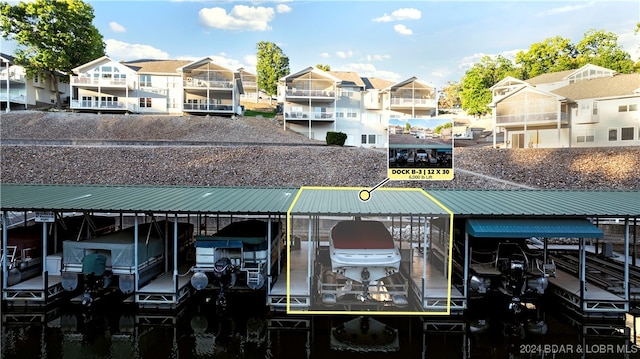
[[0, 111, 640, 190]]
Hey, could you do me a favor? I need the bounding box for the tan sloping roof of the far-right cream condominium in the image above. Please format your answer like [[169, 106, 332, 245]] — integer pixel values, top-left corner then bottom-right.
[[551, 73, 640, 100]]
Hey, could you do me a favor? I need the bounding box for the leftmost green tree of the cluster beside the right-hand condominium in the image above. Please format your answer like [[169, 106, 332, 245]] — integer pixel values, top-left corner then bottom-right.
[[460, 55, 519, 116]]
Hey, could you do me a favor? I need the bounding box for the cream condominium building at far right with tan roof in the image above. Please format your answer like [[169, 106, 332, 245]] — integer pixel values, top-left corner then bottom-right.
[[490, 65, 640, 148]]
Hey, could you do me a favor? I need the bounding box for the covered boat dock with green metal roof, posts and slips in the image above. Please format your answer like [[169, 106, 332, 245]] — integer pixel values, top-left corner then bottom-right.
[[0, 184, 640, 318]]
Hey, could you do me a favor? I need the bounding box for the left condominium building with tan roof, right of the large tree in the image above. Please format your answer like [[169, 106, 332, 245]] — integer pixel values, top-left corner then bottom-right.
[[70, 56, 243, 115]]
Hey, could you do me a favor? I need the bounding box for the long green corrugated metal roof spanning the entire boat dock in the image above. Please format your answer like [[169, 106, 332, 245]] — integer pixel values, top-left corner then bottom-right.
[[0, 183, 640, 218]]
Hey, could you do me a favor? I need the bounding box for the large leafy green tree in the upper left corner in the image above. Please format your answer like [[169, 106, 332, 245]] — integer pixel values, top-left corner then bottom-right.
[[0, 0, 105, 109]]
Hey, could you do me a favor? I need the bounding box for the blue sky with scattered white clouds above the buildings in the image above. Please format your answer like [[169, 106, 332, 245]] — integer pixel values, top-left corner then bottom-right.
[[0, 0, 640, 87]]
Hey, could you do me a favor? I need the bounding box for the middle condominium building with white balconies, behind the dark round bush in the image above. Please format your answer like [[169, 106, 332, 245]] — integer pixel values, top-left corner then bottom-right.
[[278, 67, 437, 147]]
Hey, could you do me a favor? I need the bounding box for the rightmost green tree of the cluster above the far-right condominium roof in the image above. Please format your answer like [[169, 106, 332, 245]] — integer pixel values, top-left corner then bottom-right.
[[576, 29, 634, 73]]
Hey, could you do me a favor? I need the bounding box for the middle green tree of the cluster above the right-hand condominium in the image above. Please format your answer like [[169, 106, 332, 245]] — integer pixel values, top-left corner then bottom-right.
[[516, 36, 579, 80]]
